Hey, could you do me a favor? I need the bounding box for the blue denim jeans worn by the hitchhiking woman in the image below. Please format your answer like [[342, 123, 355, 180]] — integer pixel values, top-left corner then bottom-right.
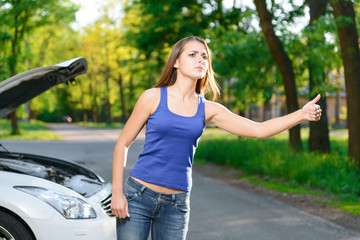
[[116, 177, 190, 240]]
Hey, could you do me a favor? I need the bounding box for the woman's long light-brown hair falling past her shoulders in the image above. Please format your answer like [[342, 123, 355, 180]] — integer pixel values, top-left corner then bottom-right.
[[155, 36, 220, 100]]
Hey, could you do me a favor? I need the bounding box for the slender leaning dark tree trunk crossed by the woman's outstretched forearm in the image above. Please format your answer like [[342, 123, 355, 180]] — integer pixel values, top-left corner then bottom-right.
[[254, 0, 302, 150]]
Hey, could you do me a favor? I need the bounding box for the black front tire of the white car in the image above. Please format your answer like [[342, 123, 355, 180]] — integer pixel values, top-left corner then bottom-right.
[[0, 210, 35, 240]]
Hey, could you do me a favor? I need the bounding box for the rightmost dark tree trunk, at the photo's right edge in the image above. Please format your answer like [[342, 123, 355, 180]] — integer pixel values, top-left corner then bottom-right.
[[330, 0, 360, 167]]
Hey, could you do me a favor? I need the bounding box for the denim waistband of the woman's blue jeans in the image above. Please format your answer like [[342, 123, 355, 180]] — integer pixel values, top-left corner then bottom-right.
[[126, 176, 190, 203]]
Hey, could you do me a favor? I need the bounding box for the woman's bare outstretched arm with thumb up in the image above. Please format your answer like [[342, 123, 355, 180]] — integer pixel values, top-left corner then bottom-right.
[[205, 94, 321, 138]]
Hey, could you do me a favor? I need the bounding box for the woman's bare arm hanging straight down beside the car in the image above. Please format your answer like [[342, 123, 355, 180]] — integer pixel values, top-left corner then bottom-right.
[[111, 88, 160, 218]]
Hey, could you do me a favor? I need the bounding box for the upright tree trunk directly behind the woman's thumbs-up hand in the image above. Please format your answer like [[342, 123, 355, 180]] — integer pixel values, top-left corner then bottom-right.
[[307, 0, 330, 152]]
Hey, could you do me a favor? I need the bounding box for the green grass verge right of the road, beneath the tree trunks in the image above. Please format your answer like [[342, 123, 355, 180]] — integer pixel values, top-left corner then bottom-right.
[[196, 129, 360, 214]]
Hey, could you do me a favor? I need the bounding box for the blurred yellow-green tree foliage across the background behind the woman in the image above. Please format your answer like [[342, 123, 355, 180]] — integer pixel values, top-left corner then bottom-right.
[[0, 0, 359, 129]]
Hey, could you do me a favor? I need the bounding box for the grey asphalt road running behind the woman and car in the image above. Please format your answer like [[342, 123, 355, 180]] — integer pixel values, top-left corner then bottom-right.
[[1, 124, 360, 240]]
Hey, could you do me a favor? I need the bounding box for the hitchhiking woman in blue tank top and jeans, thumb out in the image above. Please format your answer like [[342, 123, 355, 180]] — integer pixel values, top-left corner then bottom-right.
[[111, 36, 321, 240]]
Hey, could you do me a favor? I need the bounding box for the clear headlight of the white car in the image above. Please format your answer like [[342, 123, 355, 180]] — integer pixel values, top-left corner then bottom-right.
[[14, 186, 96, 219]]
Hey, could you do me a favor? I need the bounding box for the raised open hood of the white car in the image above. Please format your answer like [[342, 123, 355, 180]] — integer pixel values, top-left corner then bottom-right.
[[0, 57, 87, 118]]
